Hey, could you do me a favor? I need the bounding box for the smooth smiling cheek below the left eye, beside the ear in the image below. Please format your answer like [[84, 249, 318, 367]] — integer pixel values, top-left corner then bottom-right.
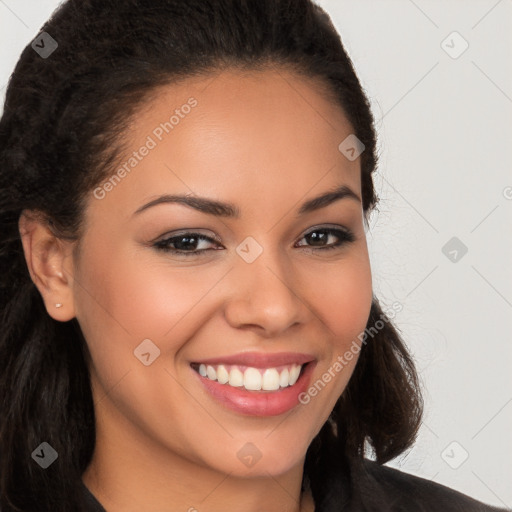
[[78, 238, 225, 342]]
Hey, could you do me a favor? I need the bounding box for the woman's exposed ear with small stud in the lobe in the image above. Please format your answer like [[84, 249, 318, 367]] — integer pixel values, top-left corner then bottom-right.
[[18, 210, 75, 322]]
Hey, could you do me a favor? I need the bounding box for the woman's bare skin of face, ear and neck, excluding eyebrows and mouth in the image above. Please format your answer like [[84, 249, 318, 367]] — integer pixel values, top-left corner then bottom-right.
[[19, 68, 372, 512]]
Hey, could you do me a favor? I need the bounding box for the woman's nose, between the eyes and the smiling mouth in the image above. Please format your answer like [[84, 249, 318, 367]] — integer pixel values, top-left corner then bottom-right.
[[225, 249, 308, 337]]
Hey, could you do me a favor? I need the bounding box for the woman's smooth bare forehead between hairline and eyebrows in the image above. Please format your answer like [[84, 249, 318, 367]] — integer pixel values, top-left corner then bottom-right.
[[89, 68, 361, 221]]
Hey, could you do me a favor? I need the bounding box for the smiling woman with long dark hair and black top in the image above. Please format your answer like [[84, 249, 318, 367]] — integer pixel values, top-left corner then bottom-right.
[[0, 0, 504, 512]]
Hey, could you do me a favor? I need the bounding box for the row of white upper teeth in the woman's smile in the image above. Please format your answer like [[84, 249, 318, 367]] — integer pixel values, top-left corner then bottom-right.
[[194, 364, 302, 391]]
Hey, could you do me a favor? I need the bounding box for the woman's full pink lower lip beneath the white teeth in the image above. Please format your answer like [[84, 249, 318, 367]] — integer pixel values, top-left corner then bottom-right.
[[192, 361, 316, 416]]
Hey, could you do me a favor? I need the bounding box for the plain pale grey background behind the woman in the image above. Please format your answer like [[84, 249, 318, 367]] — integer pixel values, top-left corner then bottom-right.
[[0, 0, 512, 507]]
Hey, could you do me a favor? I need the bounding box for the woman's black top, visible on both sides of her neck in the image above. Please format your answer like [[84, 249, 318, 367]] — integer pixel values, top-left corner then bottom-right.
[[80, 460, 512, 512]]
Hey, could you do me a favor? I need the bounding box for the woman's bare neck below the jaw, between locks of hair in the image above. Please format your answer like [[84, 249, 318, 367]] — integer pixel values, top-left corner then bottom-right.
[[83, 400, 314, 512]]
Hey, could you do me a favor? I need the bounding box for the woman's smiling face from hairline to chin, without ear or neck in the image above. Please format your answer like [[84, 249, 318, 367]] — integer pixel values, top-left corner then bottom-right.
[[73, 70, 372, 475]]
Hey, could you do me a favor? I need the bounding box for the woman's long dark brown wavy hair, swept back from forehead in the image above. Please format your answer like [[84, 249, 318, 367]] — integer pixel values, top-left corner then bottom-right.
[[0, 0, 423, 512]]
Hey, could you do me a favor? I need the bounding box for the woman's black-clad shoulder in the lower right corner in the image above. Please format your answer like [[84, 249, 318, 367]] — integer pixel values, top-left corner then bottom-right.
[[354, 459, 506, 512]]
